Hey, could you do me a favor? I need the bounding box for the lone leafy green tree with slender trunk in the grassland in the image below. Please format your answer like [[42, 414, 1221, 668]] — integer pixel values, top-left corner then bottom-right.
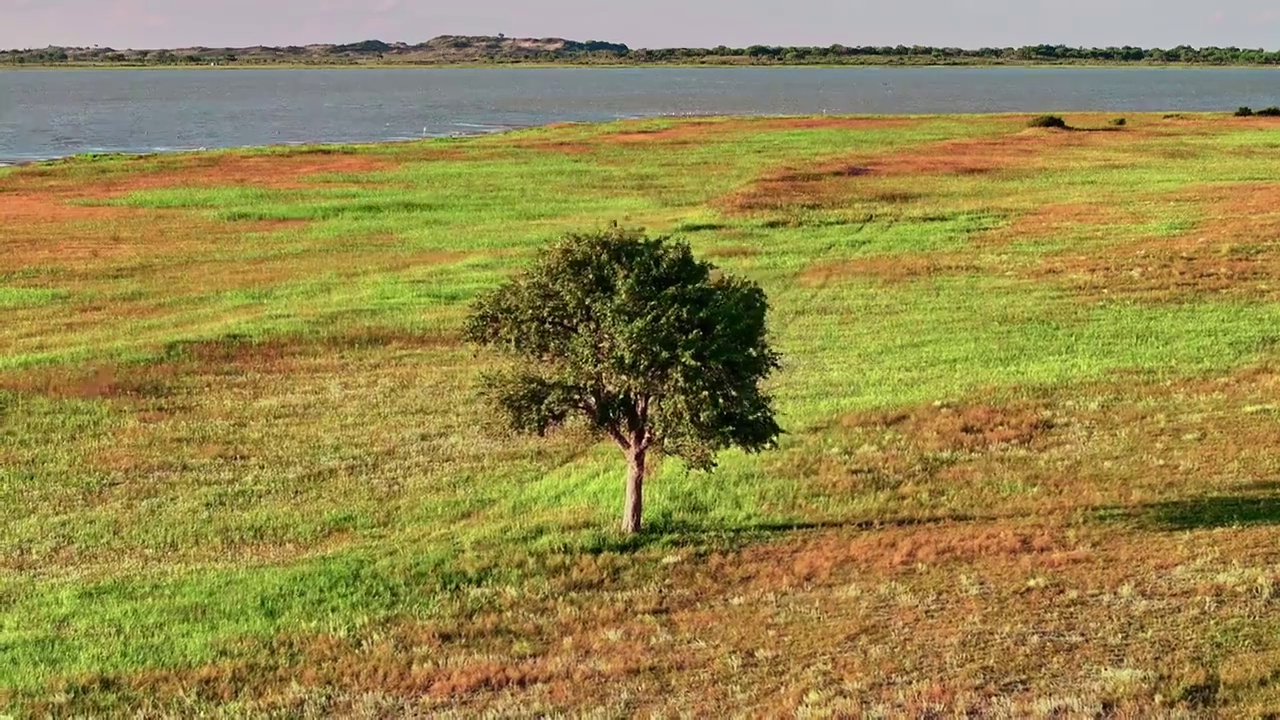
[[465, 225, 782, 533]]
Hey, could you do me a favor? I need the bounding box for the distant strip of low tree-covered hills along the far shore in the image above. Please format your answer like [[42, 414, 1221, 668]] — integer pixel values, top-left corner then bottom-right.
[[0, 35, 1280, 67]]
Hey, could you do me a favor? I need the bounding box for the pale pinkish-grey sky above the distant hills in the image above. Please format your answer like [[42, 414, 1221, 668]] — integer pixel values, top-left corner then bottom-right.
[[0, 0, 1280, 50]]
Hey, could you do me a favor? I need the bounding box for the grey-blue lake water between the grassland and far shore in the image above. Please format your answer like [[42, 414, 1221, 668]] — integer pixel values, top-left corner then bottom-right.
[[0, 68, 1280, 164]]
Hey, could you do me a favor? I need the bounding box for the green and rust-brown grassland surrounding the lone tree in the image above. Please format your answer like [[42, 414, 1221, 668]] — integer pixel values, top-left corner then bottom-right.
[[0, 115, 1280, 717]]
